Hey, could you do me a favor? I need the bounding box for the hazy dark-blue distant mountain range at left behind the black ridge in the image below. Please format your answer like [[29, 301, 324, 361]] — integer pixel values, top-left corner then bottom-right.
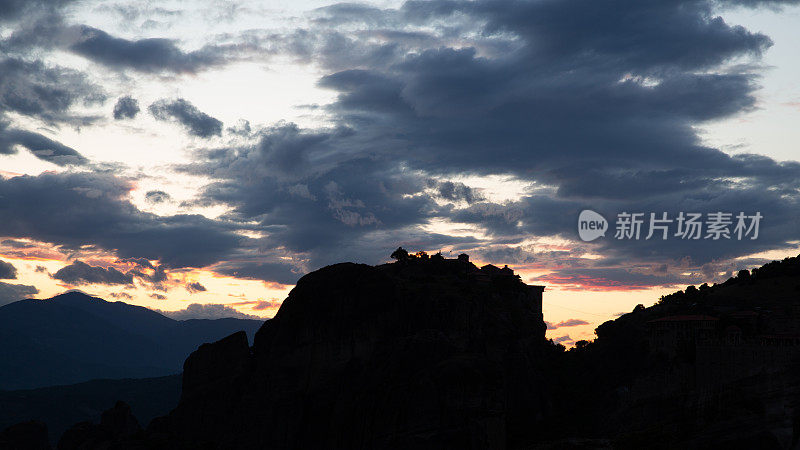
[[0, 292, 263, 390]]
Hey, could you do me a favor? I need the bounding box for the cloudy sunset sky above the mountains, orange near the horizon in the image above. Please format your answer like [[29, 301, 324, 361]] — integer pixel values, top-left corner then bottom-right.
[[0, 0, 800, 345]]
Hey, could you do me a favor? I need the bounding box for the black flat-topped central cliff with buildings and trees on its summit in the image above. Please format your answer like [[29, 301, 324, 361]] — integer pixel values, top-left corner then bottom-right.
[[162, 258, 547, 449]]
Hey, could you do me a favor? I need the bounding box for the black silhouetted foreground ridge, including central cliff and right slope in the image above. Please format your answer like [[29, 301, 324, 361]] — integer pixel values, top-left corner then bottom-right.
[[7, 252, 800, 450]]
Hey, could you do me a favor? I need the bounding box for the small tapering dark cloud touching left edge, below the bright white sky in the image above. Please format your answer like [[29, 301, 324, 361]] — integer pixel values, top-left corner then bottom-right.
[[0, 122, 88, 166]]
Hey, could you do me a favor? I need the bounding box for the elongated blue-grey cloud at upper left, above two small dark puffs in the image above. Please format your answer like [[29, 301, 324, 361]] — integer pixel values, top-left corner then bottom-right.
[[70, 26, 224, 73]]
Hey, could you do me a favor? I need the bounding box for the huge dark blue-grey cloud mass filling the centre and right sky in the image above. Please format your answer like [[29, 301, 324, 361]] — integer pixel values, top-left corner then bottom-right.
[[170, 0, 800, 286]]
